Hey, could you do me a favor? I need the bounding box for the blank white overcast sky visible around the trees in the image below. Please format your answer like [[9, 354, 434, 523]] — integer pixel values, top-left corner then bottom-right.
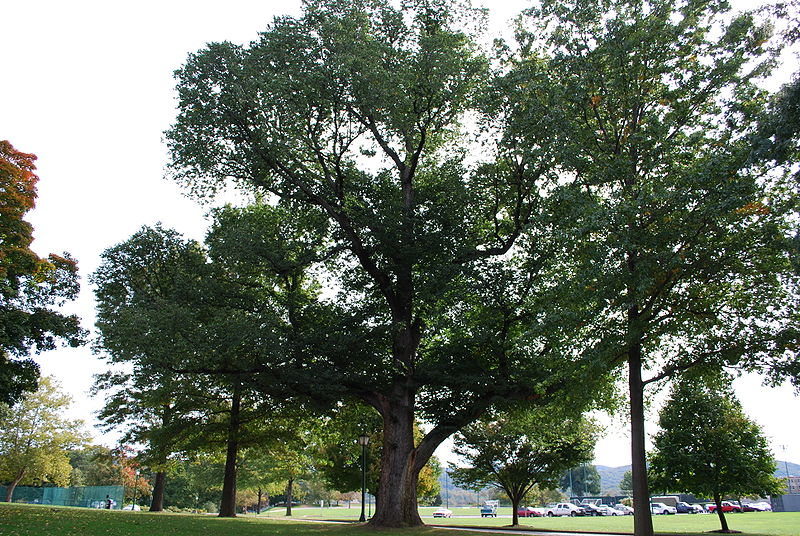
[[0, 0, 800, 466]]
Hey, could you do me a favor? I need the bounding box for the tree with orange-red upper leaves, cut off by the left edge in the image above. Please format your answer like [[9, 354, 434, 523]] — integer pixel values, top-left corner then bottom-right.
[[0, 141, 84, 405]]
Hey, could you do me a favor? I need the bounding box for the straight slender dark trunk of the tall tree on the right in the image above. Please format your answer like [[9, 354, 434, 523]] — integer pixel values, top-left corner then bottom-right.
[[628, 340, 653, 536]]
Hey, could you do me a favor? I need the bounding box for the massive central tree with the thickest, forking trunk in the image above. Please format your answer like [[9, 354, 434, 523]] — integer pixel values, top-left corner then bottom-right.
[[167, 0, 592, 526]]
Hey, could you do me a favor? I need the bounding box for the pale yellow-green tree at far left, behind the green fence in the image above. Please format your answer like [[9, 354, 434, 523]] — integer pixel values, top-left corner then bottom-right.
[[0, 377, 87, 502]]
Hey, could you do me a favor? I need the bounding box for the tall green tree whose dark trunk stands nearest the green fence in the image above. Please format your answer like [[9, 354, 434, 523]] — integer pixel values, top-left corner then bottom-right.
[[91, 226, 212, 512]]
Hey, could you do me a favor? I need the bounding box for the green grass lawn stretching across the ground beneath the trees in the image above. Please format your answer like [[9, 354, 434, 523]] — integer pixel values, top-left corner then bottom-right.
[[0, 503, 800, 536]]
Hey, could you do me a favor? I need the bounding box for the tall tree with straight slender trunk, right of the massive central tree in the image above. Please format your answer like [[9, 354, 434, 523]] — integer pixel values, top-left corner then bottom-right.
[[504, 0, 793, 536]]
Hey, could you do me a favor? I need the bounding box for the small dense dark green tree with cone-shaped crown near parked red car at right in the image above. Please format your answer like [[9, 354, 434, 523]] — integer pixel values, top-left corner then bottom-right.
[[650, 380, 781, 532]]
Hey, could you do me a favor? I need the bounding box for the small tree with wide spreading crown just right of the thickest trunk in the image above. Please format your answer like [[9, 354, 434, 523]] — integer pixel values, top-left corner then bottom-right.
[[450, 411, 595, 525]]
